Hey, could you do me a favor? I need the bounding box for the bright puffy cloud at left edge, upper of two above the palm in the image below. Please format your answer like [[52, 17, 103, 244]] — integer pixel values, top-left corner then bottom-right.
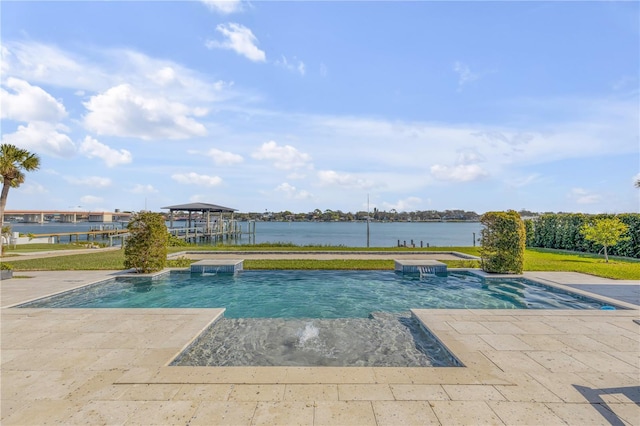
[[0, 77, 67, 122]]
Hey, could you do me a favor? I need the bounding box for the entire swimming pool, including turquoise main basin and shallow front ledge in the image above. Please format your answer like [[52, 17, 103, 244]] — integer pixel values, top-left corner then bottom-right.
[[18, 270, 616, 367]]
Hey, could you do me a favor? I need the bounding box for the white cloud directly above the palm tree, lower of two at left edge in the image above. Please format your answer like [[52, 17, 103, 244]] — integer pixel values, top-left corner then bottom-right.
[[2, 121, 76, 158]]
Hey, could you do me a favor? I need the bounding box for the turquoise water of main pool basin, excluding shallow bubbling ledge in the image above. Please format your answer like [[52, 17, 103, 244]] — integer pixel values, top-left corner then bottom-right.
[[21, 271, 602, 319]]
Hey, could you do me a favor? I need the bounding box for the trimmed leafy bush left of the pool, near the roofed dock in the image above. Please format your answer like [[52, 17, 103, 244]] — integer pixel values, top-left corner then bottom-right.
[[124, 212, 167, 273]]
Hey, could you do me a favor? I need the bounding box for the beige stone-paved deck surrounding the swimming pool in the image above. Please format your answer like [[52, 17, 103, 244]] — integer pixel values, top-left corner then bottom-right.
[[0, 271, 640, 426]]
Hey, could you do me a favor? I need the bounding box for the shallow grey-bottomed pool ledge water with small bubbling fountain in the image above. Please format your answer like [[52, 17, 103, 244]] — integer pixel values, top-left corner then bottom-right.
[[171, 312, 460, 367]]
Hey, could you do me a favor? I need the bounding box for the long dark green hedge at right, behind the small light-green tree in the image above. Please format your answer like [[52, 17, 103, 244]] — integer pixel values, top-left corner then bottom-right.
[[525, 213, 640, 259]]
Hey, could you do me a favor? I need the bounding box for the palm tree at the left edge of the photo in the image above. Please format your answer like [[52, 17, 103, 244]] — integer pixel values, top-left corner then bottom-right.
[[0, 144, 40, 226]]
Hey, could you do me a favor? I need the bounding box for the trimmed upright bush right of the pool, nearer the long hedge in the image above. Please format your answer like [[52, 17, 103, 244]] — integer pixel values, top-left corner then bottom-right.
[[480, 210, 527, 274]]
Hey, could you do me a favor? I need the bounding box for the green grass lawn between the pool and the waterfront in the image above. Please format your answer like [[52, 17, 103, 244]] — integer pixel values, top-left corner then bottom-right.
[[2, 245, 640, 280]]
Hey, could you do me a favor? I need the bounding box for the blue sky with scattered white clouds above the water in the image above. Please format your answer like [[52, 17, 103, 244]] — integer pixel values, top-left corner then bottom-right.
[[0, 0, 640, 213]]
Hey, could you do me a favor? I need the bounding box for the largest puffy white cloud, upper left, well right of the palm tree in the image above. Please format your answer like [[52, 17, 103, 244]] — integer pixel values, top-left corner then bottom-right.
[[84, 84, 207, 140]]
